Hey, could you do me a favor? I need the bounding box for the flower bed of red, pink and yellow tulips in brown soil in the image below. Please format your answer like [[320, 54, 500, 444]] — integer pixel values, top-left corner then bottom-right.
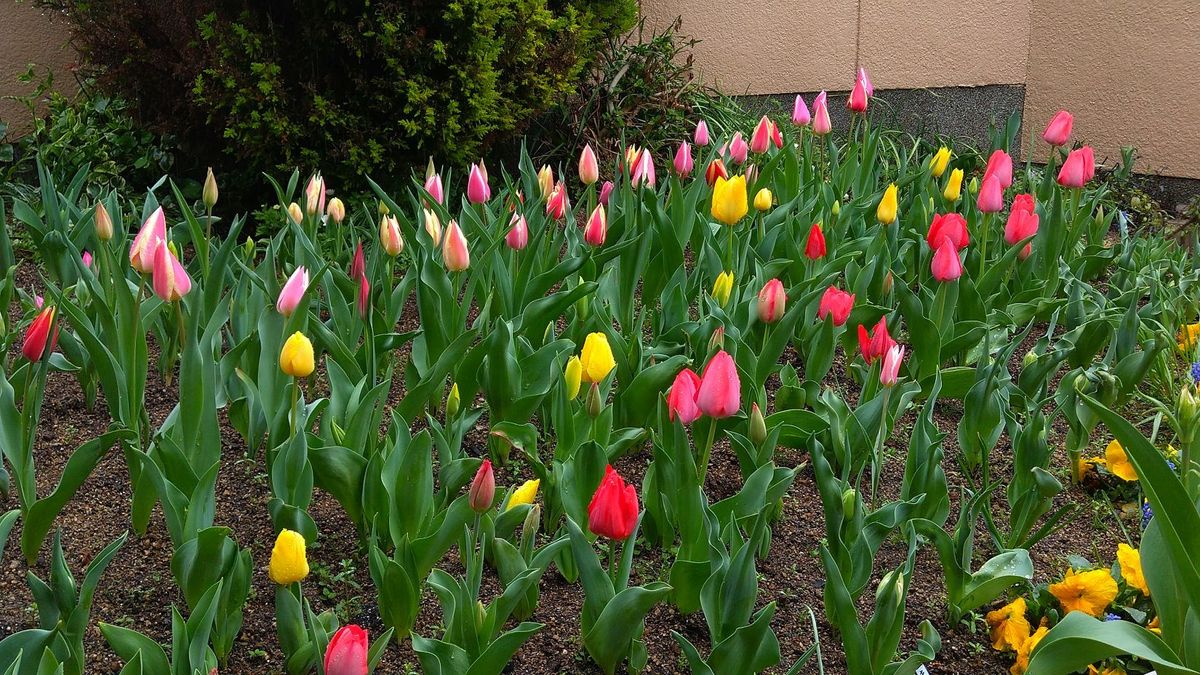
[[0, 72, 1200, 675]]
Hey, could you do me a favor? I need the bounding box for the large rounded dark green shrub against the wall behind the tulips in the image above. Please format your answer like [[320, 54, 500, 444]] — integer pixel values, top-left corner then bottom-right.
[[40, 0, 637, 190]]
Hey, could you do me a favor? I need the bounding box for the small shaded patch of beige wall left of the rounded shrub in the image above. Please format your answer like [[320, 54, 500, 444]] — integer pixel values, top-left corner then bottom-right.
[[0, 0, 76, 130]]
